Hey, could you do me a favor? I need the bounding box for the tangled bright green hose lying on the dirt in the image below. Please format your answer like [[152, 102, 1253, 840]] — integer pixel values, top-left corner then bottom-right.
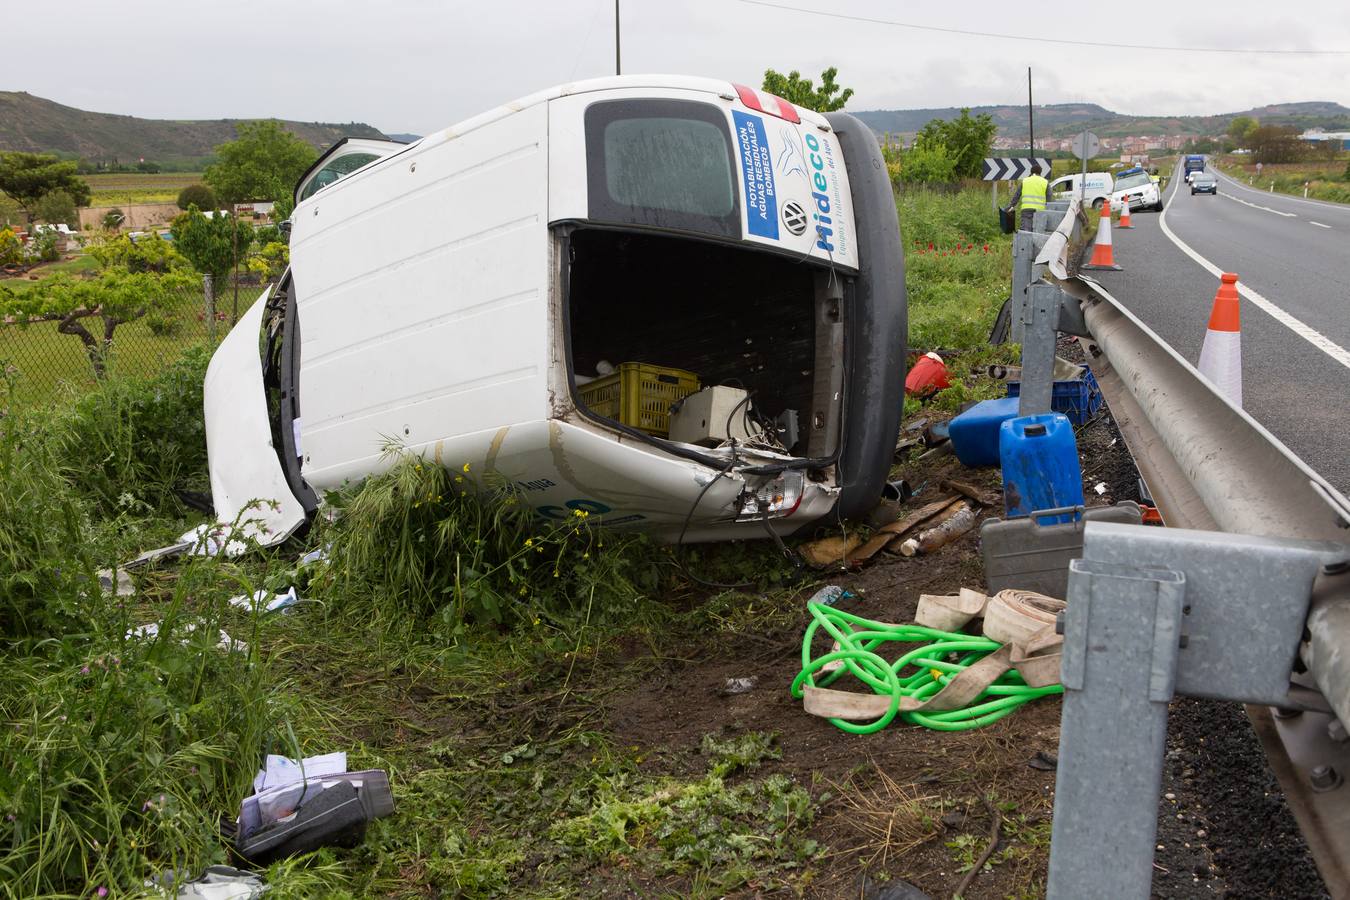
[[791, 602, 1064, 734]]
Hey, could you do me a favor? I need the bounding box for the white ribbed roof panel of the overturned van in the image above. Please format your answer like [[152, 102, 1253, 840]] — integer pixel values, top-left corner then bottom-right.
[[290, 104, 549, 490]]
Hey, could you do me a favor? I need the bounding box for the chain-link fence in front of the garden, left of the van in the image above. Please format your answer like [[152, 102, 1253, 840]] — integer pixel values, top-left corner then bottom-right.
[[0, 279, 265, 405]]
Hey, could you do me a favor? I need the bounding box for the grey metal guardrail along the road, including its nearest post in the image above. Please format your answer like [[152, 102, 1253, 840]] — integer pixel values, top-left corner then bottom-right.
[[1014, 210, 1350, 897]]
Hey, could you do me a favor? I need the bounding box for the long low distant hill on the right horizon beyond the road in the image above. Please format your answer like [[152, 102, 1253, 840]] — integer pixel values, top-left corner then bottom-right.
[[853, 101, 1350, 140]]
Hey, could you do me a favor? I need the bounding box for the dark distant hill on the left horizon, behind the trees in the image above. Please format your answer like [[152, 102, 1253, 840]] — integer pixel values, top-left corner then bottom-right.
[[0, 90, 385, 166]]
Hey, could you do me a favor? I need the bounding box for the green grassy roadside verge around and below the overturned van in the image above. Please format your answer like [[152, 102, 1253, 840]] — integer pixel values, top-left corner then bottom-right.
[[0, 180, 1050, 897]]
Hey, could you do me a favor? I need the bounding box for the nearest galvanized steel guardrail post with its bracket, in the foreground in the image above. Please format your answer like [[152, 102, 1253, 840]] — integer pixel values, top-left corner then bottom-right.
[[1046, 522, 1345, 900]]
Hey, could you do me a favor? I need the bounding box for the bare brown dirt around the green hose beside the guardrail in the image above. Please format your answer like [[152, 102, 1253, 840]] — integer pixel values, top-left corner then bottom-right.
[[606, 442, 1060, 897]]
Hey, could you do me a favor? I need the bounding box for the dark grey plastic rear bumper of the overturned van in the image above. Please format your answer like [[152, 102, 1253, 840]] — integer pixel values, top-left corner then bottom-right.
[[825, 112, 909, 518]]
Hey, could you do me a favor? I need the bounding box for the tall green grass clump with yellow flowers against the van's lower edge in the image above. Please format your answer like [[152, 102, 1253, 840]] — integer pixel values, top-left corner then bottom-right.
[[310, 451, 656, 638]]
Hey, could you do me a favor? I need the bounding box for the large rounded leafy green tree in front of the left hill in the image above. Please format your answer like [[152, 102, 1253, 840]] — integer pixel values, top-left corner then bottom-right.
[[205, 119, 319, 204]]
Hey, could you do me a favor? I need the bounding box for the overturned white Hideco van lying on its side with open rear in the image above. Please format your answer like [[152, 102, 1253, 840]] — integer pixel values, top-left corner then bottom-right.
[[205, 76, 906, 544]]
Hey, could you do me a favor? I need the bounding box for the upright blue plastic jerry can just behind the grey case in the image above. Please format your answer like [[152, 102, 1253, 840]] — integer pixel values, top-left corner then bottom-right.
[[999, 413, 1083, 525]]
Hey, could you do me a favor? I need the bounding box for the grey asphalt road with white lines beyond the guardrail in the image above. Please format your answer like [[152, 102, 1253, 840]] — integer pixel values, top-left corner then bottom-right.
[[1091, 170, 1350, 494]]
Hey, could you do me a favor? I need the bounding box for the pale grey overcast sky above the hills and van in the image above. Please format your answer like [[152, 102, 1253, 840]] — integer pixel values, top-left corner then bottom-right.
[[10, 0, 1350, 134]]
